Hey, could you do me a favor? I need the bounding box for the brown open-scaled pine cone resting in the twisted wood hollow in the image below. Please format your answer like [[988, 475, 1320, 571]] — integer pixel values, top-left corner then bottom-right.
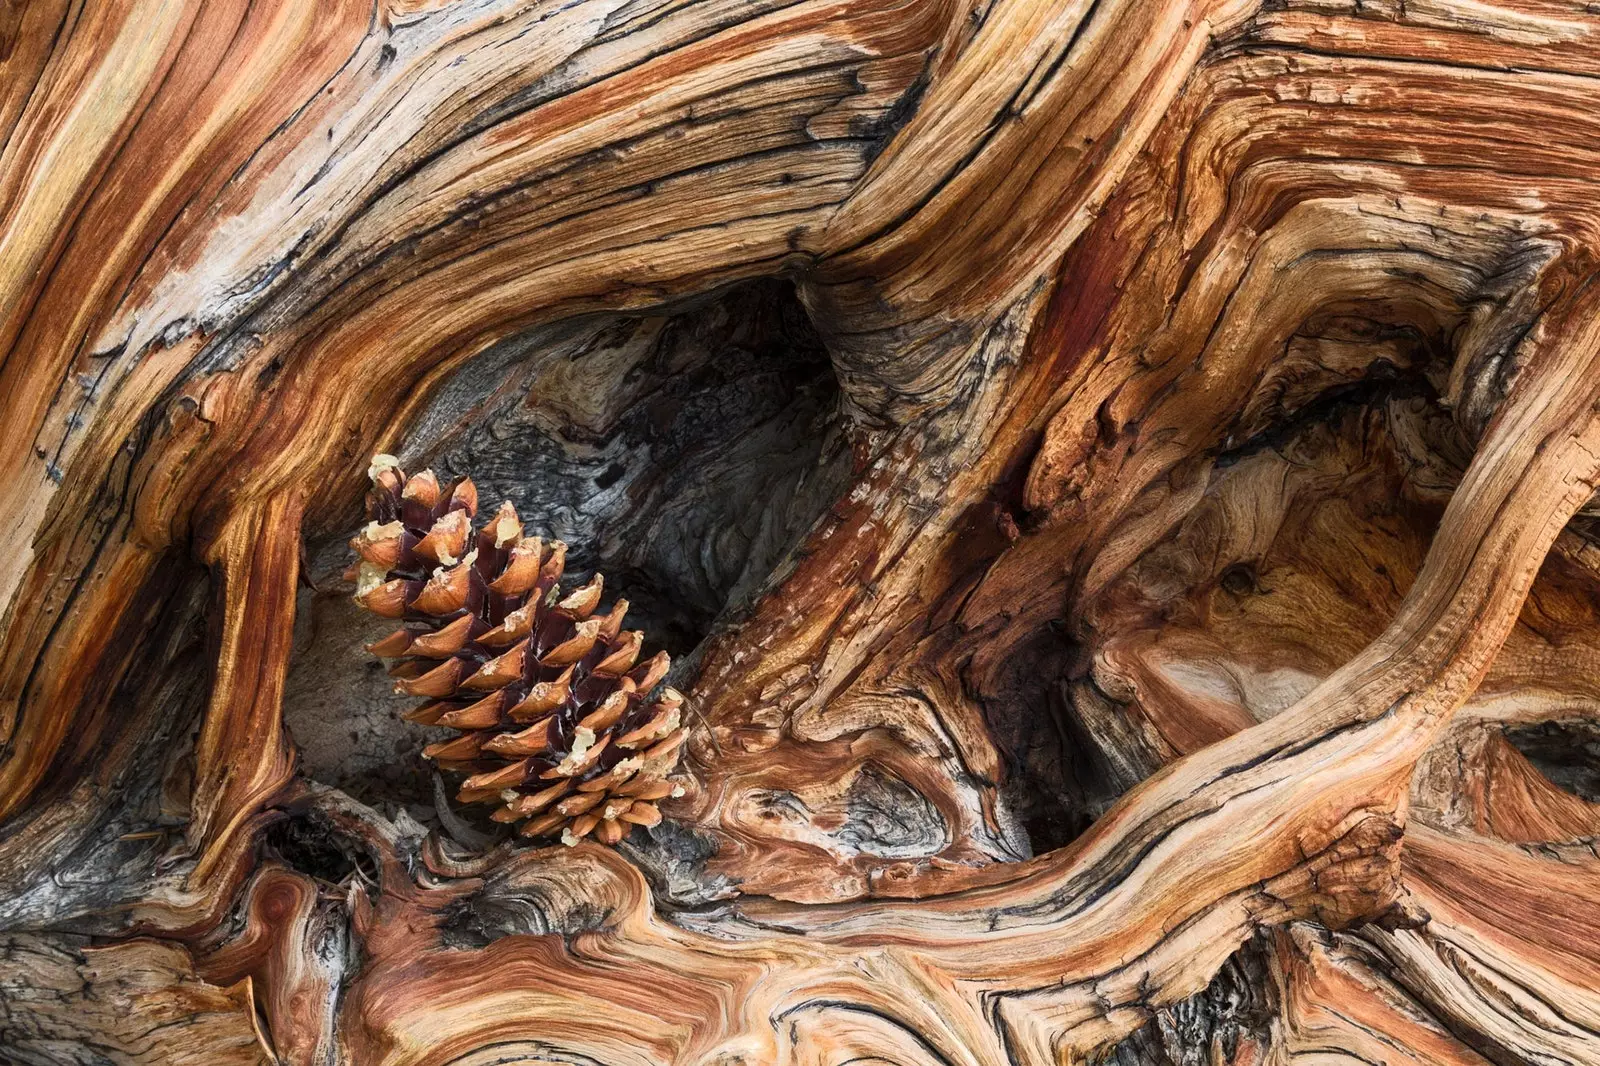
[[347, 455, 683, 844]]
